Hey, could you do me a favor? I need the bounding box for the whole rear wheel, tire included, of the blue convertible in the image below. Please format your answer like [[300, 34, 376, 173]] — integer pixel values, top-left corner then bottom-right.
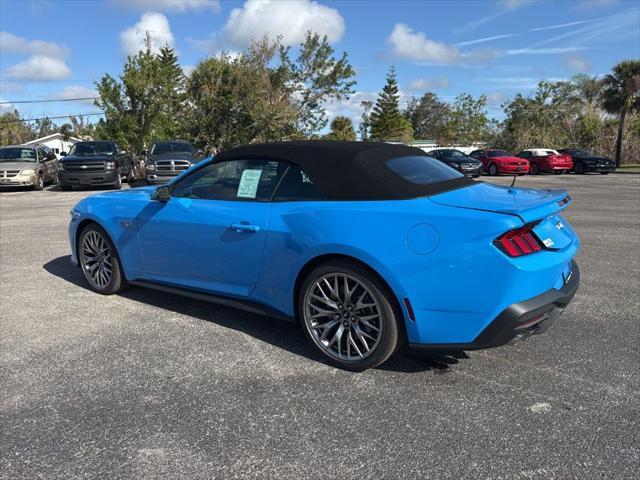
[[297, 261, 405, 372]]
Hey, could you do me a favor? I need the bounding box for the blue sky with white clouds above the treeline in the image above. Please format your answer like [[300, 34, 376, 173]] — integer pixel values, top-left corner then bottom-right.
[[0, 0, 640, 129]]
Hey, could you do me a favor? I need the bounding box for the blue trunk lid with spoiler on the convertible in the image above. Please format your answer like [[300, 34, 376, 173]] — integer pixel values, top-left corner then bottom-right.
[[430, 182, 571, 223]]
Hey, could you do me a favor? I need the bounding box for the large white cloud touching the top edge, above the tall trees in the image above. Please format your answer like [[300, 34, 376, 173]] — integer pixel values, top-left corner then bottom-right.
[[222, 0, 345, 47]]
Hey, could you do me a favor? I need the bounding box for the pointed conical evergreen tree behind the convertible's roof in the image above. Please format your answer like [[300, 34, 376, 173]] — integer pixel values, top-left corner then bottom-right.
[[371, 67, 413, 142]]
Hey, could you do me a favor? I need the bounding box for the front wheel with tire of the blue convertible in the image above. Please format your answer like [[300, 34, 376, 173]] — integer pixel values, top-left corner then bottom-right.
[[78, 223, 127, 295]]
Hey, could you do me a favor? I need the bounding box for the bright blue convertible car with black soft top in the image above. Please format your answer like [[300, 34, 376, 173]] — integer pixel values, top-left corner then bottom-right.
[[69, 141, 580, 370]]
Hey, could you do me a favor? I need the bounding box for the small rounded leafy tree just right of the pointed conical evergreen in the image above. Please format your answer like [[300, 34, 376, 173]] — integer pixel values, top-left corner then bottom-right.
[[403, 92, 451, 140]]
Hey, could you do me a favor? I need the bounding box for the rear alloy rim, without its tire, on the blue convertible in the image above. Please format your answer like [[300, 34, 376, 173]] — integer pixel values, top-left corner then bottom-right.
[[304, 273, 383, 361]]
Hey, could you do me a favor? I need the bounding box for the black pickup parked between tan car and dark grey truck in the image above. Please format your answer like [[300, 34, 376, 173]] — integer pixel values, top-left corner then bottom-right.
[[58, 141, 134, 191]]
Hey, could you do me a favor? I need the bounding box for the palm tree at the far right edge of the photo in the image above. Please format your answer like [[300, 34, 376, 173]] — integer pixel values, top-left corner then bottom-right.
[[602, 60, 640, 167]]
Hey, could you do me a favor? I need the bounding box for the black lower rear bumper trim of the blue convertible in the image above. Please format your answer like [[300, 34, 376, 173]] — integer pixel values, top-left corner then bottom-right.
[[409, 260, 580, 351]]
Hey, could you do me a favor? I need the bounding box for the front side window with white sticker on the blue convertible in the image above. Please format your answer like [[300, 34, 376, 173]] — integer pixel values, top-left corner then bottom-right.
[[172, 160, 283, 202]]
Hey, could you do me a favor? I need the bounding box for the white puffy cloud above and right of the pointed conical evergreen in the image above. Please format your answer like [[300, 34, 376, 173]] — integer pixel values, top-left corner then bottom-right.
[[387, 23, 460, 64]]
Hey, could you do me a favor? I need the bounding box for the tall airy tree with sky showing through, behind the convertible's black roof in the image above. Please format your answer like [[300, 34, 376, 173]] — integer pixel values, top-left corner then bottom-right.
[[278, 32, 356, 137]]
